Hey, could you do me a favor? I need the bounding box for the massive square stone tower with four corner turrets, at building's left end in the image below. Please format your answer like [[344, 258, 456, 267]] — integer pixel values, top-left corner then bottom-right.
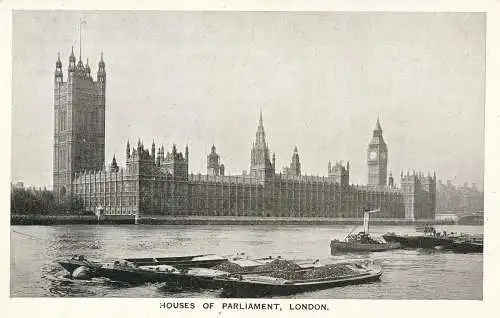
[[53, 49, 106, 197]]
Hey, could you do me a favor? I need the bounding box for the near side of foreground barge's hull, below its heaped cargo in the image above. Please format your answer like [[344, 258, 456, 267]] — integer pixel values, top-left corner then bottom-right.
[[214, 260, 382, 297]]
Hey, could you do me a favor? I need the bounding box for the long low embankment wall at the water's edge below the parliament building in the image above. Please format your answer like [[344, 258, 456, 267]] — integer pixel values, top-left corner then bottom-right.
[[10, 215, 455, 225]]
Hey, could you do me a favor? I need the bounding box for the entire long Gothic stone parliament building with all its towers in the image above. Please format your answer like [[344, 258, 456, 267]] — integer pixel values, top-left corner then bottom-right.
[[53, 50, 436, 220]]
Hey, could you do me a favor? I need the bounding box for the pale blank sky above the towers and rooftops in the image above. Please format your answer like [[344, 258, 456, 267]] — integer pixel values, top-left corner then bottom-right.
[[11, 11, 486, 188]]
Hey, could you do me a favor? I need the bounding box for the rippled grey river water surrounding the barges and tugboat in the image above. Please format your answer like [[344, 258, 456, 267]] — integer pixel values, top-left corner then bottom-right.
[[10, 225, 483, 299]]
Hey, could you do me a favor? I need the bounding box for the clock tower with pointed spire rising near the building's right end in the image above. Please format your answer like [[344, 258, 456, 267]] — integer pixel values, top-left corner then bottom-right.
[[367, 117, 387, 186]]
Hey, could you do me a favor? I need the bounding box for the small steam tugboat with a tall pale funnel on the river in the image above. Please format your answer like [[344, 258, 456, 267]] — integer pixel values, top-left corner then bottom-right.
[[330, 209, 401, 254]]
